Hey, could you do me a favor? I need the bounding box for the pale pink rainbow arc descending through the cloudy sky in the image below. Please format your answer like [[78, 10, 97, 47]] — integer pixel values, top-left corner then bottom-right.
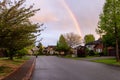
[[61, 0, 82, 36]]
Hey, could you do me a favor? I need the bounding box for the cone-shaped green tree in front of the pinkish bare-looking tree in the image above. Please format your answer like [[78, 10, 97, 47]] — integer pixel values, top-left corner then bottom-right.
[[56, 35, 70, 52]]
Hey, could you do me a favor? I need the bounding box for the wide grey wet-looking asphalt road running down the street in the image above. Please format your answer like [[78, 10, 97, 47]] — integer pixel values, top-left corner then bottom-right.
[[32, 56, 120, 80]]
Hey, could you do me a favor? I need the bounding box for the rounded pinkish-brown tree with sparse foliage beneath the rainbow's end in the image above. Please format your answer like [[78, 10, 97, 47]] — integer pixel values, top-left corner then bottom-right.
[[64, 33, 82, 47]]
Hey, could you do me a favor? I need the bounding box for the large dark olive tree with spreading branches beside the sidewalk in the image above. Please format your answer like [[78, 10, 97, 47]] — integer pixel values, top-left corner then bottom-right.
[[0, 0, 41, 60]]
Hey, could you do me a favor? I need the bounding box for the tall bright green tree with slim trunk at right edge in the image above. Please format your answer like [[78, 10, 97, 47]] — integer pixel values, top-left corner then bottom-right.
[[96, 0, 120, 61]]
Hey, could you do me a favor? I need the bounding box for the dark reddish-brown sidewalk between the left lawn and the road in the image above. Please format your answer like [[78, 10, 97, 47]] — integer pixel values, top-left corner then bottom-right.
[[2, 57, 36, 80]]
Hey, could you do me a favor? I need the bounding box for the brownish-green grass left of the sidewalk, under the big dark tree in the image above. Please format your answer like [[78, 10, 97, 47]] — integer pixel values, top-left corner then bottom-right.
[[0, 57, 29, 79]]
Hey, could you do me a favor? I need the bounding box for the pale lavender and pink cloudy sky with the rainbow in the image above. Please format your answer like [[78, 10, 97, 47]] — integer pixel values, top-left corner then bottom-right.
[[26, 0, 105, 46]]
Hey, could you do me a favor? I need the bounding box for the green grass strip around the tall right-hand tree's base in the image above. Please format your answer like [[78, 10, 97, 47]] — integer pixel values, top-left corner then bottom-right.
[[92, 58, 120, 66]]
